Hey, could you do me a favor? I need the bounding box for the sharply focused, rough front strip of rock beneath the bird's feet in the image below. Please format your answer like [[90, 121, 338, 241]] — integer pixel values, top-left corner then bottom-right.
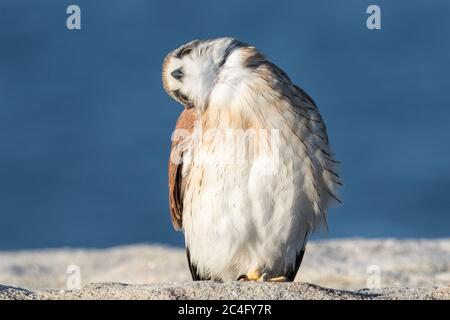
[[0, 281, 450, 300]]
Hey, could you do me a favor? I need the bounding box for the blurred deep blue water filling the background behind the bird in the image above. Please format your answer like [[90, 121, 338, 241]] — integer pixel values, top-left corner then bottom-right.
[[0, 0, 450, 249]]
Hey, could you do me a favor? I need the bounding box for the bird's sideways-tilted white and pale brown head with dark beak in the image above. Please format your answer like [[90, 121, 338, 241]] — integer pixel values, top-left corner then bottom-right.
[[162, 38, 260, 110]]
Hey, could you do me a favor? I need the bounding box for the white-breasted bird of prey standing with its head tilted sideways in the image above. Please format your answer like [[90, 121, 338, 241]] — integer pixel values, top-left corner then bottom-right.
[[162, 37, 342, 282]]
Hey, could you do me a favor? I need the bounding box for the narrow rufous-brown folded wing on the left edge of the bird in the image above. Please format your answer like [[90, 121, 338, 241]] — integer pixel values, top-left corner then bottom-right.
[[169, 109, 196, 230]]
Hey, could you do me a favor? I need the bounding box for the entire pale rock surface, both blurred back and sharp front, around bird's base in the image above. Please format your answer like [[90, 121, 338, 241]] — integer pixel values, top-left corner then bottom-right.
[[0, 239, 450, 299]]
